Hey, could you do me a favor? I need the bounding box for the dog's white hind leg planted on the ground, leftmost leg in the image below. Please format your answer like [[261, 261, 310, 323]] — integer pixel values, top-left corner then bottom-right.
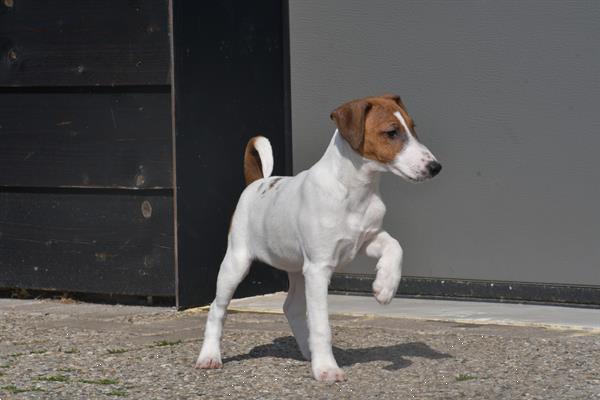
[[196, 245, 252, 368]]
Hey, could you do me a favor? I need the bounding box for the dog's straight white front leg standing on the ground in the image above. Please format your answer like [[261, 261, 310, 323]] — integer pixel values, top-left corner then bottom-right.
[[302, 264, 344, 382]]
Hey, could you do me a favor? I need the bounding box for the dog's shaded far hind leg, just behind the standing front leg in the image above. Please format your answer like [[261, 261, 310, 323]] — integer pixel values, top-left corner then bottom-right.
[[283, 271, 310, 360]]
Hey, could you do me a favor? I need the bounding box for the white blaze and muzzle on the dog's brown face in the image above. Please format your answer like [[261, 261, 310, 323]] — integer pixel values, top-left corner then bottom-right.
[[391, 111, 435, 180]]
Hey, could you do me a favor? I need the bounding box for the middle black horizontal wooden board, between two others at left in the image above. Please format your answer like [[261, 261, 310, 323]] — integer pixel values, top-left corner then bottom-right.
[[0, 93, 173, 188]]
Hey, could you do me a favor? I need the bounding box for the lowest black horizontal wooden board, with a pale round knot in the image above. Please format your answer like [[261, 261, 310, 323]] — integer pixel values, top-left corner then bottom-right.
[[0, 191, 175, 296]]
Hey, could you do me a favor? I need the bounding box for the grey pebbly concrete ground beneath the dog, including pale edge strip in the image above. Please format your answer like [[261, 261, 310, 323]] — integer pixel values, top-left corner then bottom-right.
[[0, 294, 600, 400]]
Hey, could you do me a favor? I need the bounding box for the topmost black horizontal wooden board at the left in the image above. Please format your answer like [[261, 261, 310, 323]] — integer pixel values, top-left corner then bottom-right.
[[0, 0, 170, 86]]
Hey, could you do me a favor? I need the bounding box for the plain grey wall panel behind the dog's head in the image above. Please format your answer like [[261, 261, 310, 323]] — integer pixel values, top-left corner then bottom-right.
[[290, 0, 600, 285]]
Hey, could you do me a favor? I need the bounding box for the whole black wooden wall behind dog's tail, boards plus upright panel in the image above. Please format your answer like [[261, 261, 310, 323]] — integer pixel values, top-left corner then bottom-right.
[[0, 0, 291, 308]]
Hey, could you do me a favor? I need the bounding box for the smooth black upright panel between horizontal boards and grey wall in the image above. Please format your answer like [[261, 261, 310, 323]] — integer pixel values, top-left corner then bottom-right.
[[173, 0, 291, 308]]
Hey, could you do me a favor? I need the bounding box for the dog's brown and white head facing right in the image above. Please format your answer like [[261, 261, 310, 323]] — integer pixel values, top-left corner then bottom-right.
[[331, 95, 442, 182]]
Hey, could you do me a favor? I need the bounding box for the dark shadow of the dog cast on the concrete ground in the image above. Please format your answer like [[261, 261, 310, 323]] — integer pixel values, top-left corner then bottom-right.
[[223, 336, 452, 371]]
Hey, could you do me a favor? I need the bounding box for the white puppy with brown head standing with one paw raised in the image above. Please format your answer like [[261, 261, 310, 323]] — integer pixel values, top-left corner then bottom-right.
[[196, 95, 442, 382]]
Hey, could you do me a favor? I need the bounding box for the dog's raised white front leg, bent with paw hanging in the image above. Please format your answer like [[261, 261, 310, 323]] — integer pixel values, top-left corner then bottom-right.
[[365, 231, 402, 304]]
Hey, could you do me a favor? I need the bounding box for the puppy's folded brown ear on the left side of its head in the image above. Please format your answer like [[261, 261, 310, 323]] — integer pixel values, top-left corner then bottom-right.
[[330, 99, 371, 150]]
